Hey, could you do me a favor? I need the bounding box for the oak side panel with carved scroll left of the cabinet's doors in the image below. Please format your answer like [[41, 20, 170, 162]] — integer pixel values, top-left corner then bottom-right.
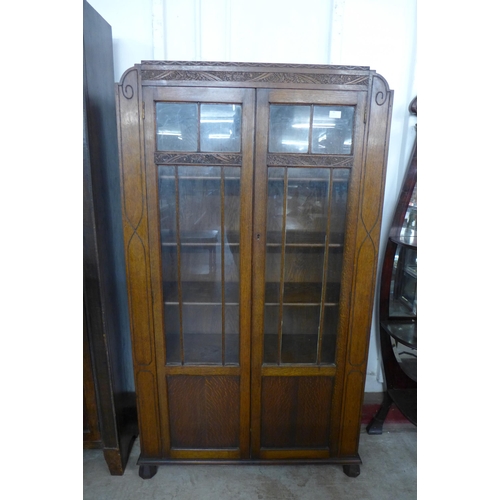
[[116, 68, 162, 458]]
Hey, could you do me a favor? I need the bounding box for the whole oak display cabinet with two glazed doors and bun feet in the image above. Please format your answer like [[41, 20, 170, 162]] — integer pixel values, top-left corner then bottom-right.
[[116, 61, 392, 478]]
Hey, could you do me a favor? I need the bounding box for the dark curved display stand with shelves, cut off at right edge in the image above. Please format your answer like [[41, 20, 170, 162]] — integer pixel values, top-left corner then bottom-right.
[[366, 97, 417, 434]]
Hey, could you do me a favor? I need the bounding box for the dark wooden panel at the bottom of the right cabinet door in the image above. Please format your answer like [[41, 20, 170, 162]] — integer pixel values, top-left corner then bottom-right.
[[261, 377, 333, 448]]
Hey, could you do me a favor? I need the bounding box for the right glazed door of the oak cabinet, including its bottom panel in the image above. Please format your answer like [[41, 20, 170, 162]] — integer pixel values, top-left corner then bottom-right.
[[251, 89, 366, 459]]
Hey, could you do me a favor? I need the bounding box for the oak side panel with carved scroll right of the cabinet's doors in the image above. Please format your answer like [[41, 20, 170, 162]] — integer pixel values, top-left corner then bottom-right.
[[339, 74, 392, 456]]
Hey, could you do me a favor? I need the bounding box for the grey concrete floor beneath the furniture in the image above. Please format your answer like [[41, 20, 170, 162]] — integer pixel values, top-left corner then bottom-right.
[[83, 423, 417, 500]]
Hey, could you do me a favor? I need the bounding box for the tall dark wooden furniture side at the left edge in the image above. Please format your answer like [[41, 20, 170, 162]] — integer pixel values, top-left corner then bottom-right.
[[82, 1, 138, 475]]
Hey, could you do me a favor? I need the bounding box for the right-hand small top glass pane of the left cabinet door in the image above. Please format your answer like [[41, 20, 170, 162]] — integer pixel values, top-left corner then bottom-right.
[[200, 104, 241, 152]]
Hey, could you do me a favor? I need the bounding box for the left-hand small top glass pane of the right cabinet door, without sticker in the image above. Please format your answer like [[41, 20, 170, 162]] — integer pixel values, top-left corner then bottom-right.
[[269, 104, 311, 153]]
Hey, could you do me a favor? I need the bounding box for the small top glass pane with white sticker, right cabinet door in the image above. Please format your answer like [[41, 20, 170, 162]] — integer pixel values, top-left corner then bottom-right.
[[311, 106, 354, 154]]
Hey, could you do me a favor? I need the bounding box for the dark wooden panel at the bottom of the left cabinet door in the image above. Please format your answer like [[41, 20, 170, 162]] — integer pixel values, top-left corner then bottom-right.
[[167, 375, 240, 449]]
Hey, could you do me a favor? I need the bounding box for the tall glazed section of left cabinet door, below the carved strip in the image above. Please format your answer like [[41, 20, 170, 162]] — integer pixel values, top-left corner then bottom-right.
[[158, 166, 240, 364]]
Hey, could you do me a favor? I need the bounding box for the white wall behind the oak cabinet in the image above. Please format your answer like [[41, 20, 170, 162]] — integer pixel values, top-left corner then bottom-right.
[[89, 0, 417, 392]]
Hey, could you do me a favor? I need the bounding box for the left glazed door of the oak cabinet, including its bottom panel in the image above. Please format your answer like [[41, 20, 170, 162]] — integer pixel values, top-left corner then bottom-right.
[[143, 87, 255, 460]]
